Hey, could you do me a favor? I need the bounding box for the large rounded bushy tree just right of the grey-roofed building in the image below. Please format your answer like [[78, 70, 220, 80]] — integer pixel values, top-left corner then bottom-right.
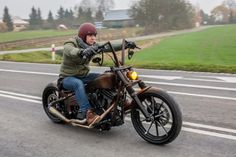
[[131, 0, 194, 33]]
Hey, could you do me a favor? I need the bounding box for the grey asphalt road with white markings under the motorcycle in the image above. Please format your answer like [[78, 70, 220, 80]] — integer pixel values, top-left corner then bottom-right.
[[0, 62, 236, 157]]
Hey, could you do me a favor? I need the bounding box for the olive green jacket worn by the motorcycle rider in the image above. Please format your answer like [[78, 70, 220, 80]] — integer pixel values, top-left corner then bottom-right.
[[60, 37, 122, 77]]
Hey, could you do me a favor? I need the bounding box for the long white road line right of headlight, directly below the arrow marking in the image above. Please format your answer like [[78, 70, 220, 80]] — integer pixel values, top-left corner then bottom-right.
[[144, 81, 236, 91]]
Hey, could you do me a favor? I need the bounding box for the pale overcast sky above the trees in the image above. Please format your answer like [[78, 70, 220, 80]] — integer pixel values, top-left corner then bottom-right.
[[0, 0, 223, 19]]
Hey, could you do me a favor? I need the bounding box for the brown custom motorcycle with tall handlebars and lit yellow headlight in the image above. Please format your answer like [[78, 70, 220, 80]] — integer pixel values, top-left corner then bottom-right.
[[42, 41, 182, 145]]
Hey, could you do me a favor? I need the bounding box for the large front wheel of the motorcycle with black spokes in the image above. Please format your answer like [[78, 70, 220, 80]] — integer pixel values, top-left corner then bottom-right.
[[131, 90, 182, 145]]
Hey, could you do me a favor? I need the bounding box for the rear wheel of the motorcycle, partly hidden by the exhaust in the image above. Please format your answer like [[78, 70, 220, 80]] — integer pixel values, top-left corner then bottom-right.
[[43, 86, 63, 123]]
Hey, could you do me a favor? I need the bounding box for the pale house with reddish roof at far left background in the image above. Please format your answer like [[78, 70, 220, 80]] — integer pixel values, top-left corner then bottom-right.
[[0, 17, 29, 31]]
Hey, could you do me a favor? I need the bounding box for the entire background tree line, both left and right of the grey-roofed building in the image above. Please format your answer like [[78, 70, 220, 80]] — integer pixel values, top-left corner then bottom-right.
[[0, 0, 236, 33]]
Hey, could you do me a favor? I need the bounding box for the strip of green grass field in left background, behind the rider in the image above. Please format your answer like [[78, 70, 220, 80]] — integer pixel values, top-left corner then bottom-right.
[[0, 30, 77, 43]]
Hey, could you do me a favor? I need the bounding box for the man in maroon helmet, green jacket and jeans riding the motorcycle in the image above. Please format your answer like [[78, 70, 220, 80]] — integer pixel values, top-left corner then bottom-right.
[[60, 23, 136, 125]]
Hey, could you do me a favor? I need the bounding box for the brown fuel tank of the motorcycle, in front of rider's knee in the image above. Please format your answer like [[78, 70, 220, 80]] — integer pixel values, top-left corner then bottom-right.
[[86, 73, 116, 91]]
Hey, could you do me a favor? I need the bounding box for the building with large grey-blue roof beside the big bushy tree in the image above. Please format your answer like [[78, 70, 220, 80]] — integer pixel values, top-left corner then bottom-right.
[[103, 9, 135, 28]]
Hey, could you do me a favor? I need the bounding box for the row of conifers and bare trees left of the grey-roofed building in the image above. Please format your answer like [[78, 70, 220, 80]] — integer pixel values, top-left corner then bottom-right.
[[0, 0, 114, 32]]
